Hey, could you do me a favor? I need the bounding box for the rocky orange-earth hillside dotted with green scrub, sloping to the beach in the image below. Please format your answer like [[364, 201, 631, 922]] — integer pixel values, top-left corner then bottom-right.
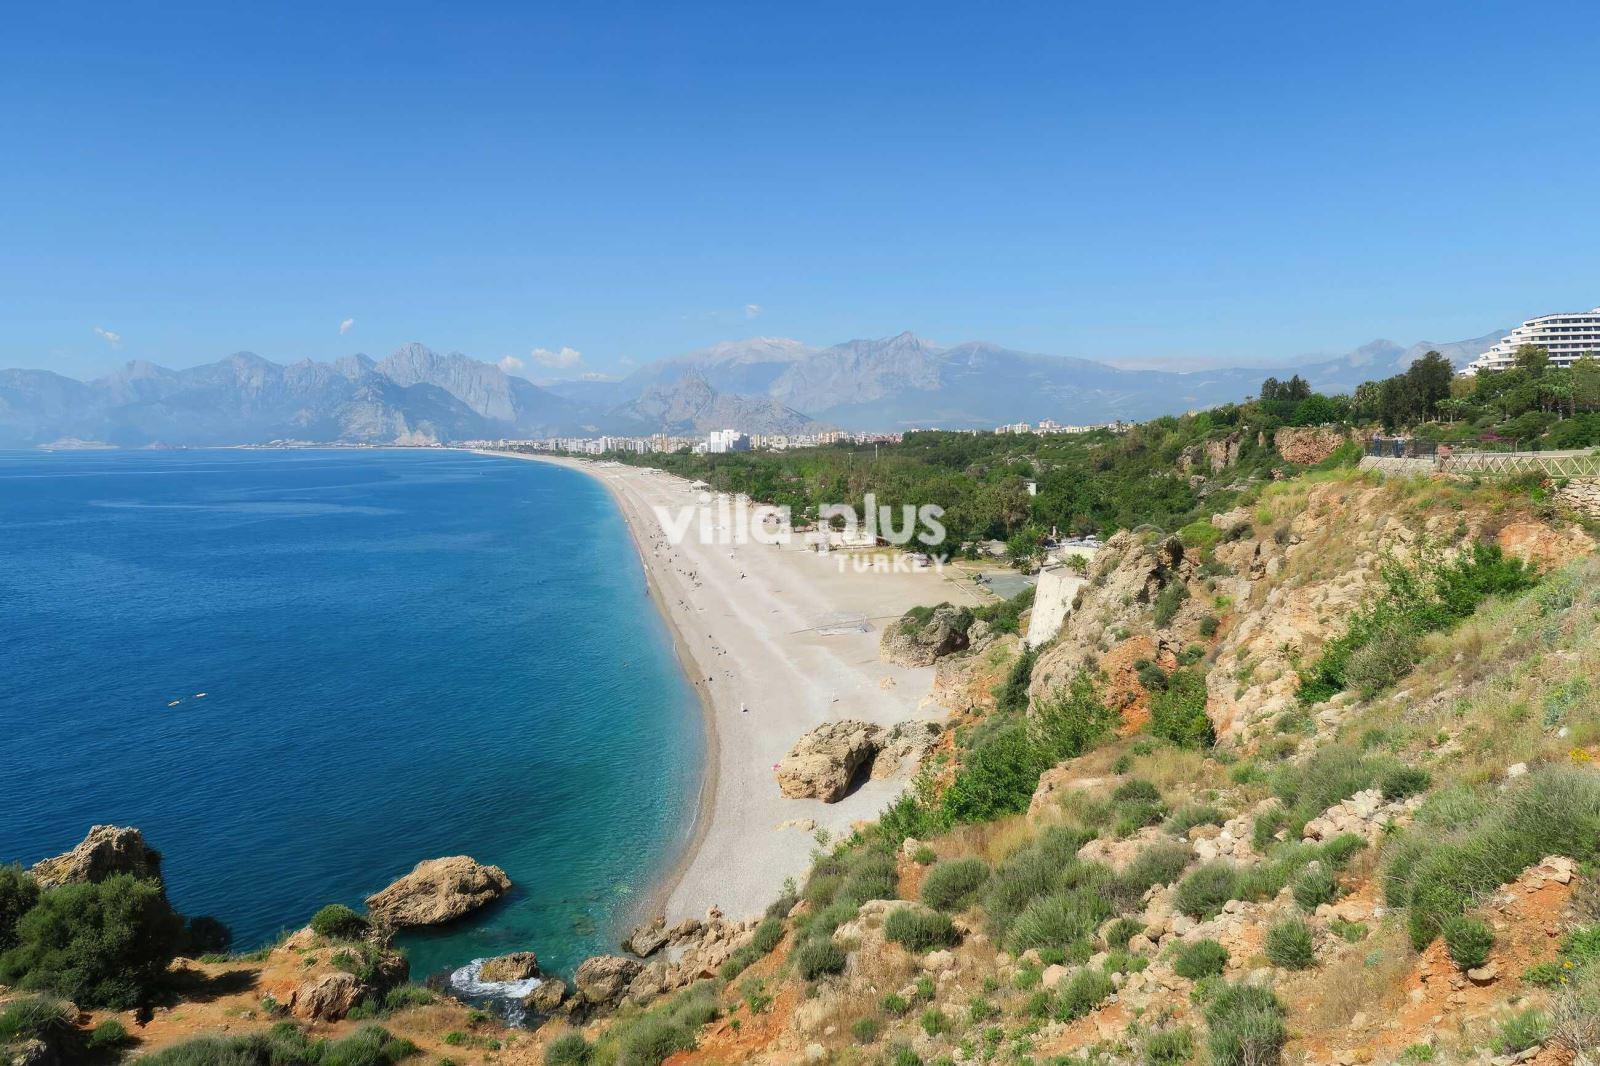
[[18, 474, 1600, 1066]]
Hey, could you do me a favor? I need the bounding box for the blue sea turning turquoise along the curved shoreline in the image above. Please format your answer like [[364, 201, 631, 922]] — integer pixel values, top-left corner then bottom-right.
[[0, 451, 702, 980]]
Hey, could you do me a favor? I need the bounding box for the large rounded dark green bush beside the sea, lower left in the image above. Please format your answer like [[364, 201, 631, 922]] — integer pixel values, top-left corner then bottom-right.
[[0, 874, 184, 1010]]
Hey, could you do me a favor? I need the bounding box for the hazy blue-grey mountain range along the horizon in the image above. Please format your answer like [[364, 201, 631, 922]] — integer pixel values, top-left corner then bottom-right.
[[0, 331, 1504, 448]]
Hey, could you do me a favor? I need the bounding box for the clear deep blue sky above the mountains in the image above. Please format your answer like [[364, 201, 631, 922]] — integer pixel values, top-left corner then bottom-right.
[[0, 2, 1600, 376]]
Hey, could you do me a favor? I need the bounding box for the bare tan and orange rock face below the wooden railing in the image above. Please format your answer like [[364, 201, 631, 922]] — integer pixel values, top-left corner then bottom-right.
[[1030, 477, 1594, 743]]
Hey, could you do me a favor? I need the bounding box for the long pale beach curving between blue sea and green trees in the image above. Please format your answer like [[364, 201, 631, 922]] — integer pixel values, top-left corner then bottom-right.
[[485, 451, 981, 922]]
